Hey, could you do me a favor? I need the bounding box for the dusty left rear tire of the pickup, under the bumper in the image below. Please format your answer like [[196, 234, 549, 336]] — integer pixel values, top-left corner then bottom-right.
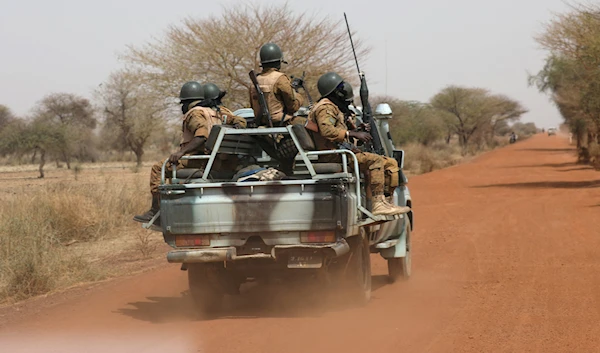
[[187, 263, 224, 318]]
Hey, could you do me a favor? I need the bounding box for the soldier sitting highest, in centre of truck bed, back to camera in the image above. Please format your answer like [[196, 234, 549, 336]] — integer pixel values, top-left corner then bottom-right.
[[250, 43, 306, 175]]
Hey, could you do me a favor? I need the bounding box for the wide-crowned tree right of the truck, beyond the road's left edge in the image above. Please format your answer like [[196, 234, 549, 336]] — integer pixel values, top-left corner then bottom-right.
[[431, 86, 527, 148]]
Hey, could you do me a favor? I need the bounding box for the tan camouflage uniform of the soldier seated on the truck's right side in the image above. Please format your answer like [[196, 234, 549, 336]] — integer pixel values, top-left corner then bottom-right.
[[308, 98, 390, 196]]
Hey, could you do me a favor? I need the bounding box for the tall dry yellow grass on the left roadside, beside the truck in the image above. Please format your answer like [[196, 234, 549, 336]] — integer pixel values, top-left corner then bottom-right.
[[0, 166, 161, 302]]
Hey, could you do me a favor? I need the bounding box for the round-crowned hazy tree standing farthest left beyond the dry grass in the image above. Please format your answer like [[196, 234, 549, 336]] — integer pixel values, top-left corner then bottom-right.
[[34, 93, 96, 169]]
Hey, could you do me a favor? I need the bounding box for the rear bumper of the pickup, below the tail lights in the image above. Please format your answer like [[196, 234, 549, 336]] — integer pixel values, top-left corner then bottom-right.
[[167, 239, 350, 263]]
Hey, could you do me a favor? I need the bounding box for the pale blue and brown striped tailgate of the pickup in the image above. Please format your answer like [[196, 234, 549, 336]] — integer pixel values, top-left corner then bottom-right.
[[161, 181, 345, 234]]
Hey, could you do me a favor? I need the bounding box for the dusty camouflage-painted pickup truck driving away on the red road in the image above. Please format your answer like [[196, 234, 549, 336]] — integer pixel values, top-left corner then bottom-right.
[[144, 104, 414, 314]]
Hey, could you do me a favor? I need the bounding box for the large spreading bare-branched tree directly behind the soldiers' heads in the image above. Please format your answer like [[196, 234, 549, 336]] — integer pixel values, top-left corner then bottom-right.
[[124, 3, 368, 108]]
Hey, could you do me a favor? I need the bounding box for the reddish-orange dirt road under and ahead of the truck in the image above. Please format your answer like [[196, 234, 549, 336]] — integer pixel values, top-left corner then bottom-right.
[[0, 135, 600, 353]]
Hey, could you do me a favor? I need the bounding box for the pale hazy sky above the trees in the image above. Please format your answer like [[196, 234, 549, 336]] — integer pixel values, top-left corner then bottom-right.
[[0, 0, 566, 127]]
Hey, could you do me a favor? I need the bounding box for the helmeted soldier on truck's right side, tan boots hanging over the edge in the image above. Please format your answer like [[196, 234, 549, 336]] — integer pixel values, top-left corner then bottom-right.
[[308, 72, 410, 215]]
